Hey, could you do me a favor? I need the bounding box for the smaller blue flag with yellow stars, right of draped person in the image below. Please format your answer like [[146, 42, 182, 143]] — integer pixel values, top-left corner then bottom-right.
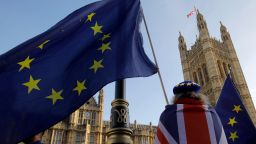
[[215, 75, 256, 144]]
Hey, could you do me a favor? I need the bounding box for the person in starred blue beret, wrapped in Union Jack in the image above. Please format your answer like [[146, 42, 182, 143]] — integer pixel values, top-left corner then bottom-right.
[[154, 81, 227, 144]]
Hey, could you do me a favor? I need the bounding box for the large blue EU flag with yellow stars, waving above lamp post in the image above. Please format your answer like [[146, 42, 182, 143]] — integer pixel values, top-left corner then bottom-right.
[[0, 0, 157, 144]]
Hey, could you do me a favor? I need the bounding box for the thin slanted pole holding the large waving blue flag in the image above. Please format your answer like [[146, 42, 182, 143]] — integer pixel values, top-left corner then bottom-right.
[[141, 9, 169, 105]]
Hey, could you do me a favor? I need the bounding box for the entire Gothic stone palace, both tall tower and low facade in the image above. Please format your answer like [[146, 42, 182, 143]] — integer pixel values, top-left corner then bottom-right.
[[43, 11, 256, 144]]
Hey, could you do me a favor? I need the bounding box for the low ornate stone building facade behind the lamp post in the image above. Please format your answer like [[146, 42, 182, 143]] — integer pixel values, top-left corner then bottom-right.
[[43, 90, 156, 144]]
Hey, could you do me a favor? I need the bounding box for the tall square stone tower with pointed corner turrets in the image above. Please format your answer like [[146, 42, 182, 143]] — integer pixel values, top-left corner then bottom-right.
[[178, 11, 256, 124]]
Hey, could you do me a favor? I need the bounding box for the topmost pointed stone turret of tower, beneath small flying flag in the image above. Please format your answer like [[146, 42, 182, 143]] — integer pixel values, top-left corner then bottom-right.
[[197, 10, 210, 40]]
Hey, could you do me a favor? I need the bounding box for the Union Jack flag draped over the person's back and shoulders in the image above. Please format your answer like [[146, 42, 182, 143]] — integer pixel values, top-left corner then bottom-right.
[[154, 104, 227, 144]]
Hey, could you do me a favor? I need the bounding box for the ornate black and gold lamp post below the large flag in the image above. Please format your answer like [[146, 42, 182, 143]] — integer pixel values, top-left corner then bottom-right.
[[107, 80, 133, 144]]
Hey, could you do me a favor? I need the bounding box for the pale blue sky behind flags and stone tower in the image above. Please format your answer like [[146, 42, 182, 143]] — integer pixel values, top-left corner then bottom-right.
[[0, 0, 256, 125]]
